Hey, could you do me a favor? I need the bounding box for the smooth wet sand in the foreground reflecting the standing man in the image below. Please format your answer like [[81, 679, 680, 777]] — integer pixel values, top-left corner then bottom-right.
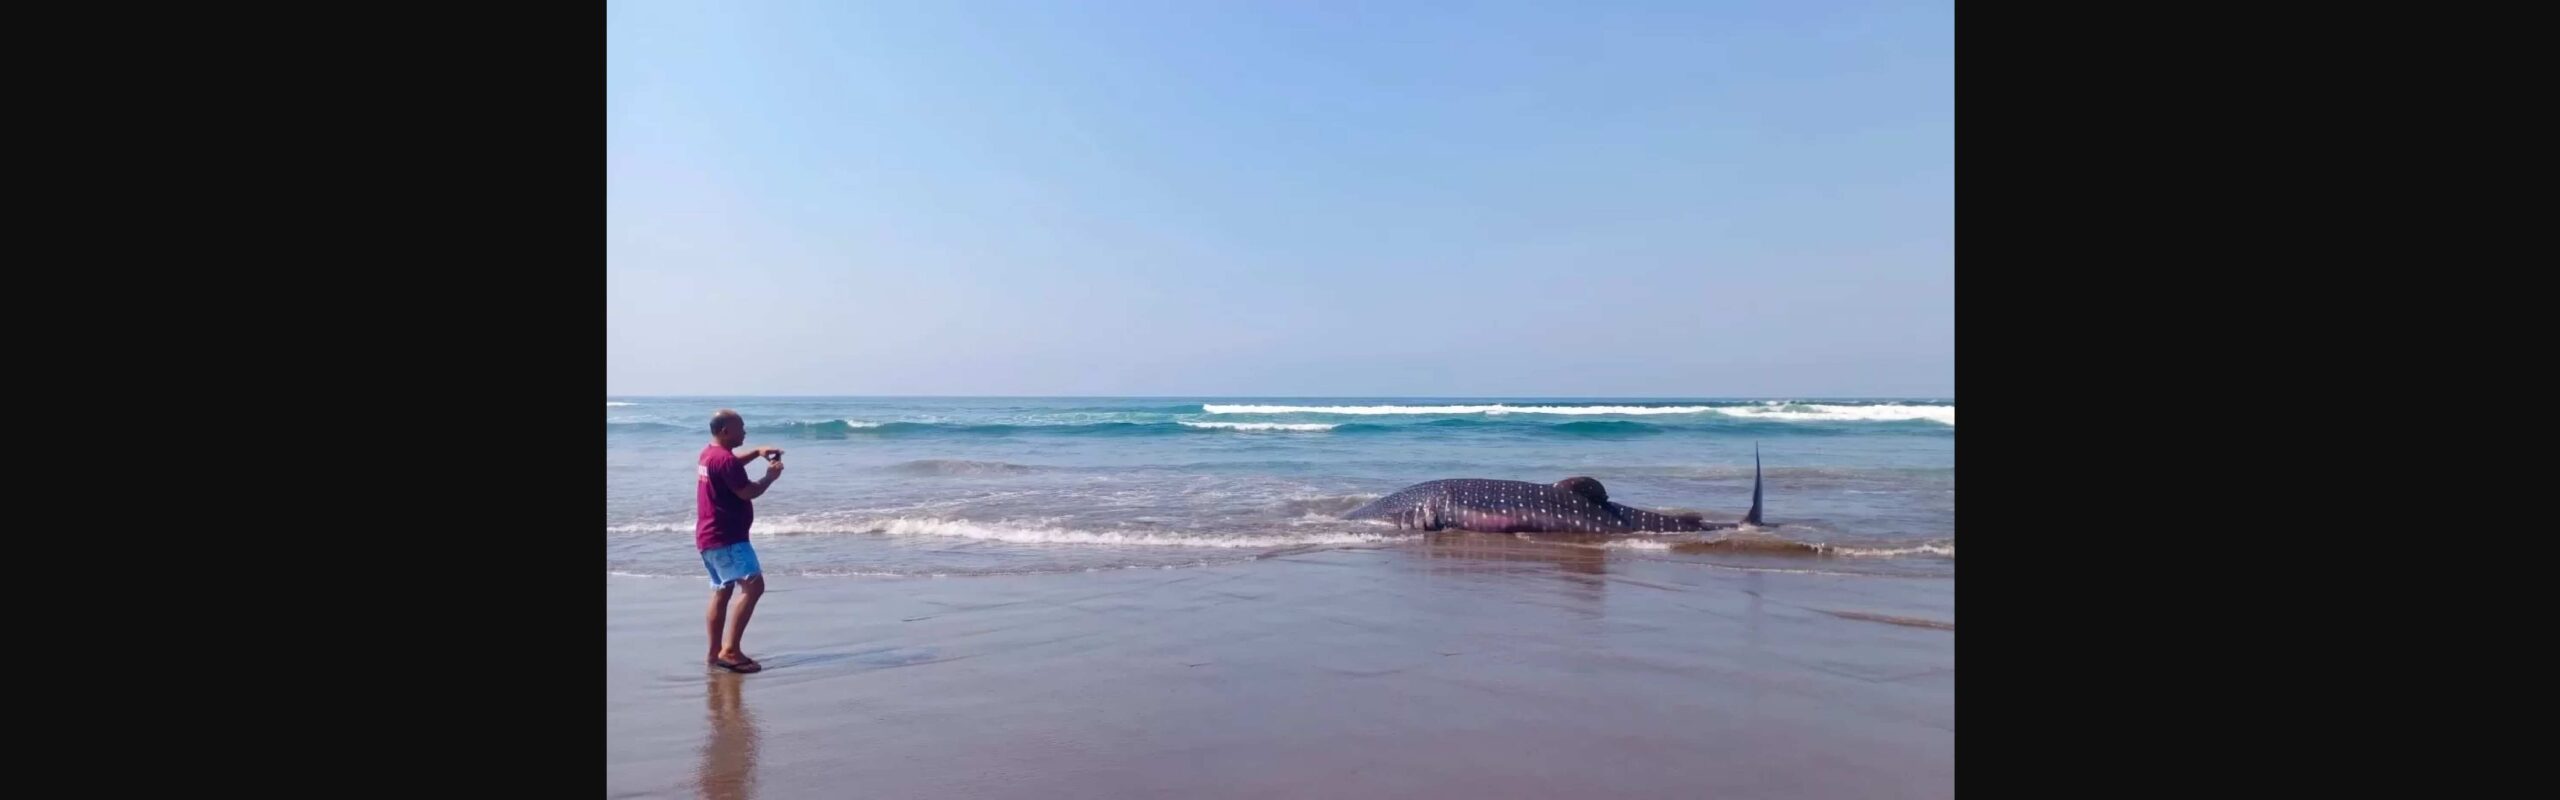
[[604, 533, 1956, 797]]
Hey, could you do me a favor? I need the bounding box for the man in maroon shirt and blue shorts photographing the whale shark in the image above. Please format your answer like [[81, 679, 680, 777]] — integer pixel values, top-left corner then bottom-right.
[[694, 408, 783, 672]]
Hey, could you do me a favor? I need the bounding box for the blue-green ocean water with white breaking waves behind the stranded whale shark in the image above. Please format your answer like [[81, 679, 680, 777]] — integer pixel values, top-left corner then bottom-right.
[[604, 397, 1956, 579]]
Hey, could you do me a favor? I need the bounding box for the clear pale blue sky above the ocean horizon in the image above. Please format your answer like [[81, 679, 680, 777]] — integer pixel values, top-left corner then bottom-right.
[[604, 0, 1956, 397]]
